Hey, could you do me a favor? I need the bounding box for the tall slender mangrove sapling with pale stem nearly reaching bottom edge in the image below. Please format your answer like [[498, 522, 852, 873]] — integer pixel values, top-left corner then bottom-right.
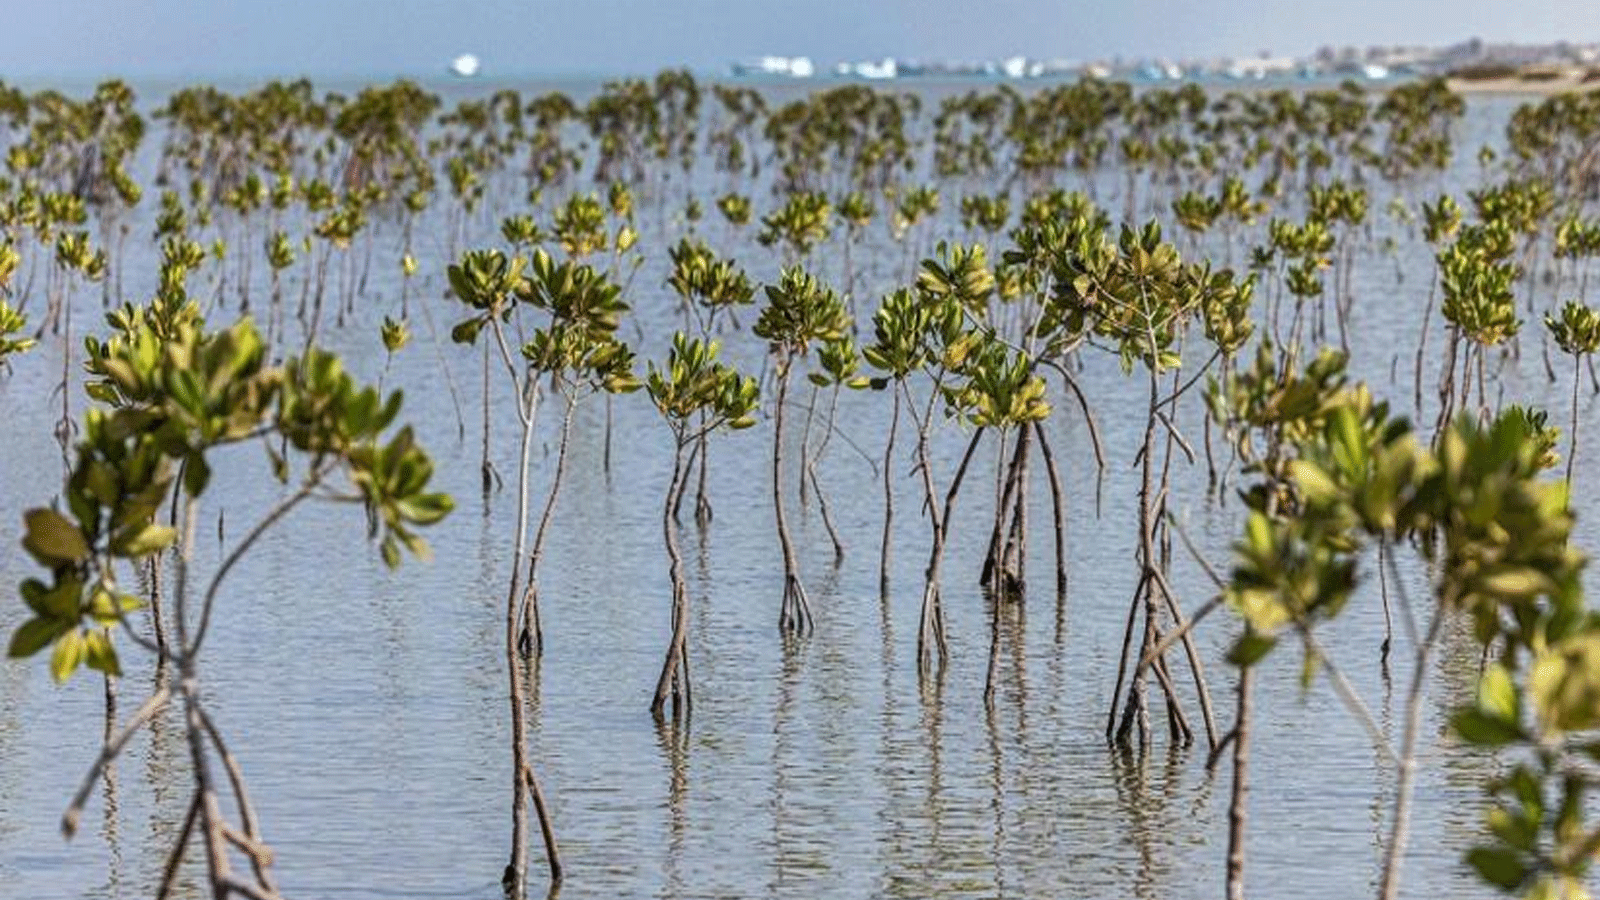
[[450, 250, 562, 898]]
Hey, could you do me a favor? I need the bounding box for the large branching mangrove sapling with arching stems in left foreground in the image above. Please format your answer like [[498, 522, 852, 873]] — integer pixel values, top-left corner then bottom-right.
[[10, 313, 451, 898]]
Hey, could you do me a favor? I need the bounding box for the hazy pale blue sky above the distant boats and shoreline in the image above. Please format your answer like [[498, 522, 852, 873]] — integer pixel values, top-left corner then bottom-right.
[[0, 0, 1600, 78]]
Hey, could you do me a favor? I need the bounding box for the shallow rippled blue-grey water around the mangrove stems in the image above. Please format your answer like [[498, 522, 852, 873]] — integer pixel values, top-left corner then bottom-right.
[[0, 85, 1600, 900]]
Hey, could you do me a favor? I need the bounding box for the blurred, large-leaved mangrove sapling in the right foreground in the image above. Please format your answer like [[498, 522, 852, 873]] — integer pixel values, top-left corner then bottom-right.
[[1229, 389, 1595, 900]]
